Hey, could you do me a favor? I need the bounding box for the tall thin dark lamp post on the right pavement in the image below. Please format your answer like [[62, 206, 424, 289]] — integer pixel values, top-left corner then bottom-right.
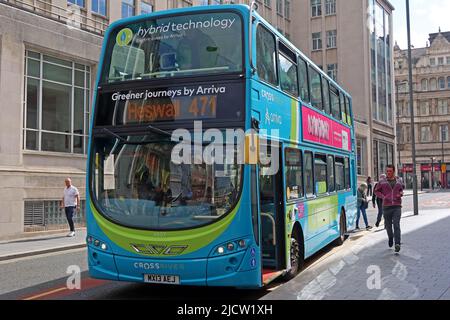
[[406, 0, 419, 216]]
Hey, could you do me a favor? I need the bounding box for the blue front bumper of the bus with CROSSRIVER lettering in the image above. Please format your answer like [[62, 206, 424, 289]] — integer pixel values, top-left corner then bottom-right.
[[88, 246, 261, 288]]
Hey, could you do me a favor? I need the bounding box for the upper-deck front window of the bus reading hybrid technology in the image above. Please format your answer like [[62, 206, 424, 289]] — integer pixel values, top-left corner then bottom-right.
[[102, 12, 243, 82]]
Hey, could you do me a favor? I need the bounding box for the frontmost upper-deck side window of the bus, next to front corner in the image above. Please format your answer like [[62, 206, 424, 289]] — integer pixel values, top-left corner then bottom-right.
[[256, 25, 278, 86]]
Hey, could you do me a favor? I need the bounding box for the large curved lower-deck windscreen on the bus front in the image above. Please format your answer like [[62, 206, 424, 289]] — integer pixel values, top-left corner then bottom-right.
[[91, 134, 243, 230]]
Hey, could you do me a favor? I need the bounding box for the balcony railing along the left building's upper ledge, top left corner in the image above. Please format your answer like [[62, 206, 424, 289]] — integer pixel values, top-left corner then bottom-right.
[[0, 0, 109, 36]]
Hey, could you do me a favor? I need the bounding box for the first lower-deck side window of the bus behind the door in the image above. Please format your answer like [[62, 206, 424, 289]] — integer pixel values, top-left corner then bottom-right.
[[285, 149, 303, 201]]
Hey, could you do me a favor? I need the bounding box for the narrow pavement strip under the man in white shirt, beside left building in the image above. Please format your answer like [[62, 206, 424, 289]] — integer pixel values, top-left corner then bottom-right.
[[0, 228, 86, 261]]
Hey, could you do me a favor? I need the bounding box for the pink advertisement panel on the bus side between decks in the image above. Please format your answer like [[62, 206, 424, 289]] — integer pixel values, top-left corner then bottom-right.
[[302, 106, 352, 151]]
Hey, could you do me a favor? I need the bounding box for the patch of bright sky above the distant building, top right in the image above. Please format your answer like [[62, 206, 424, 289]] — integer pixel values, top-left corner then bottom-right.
[[389, 0, 450, 49]]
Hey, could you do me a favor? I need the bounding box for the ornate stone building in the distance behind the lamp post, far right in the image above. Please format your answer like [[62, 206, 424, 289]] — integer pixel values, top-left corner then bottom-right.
[[394, 31, 450, 189]]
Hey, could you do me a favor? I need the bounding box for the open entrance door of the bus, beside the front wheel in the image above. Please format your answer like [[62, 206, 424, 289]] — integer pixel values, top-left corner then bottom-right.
[[259, 147, 286, 283]]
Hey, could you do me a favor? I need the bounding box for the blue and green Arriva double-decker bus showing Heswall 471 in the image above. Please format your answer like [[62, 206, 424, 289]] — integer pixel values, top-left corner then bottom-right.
[[86, 5, 356, 288]]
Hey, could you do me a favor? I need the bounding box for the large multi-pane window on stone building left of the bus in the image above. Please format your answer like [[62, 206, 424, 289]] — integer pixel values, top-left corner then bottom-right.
[[24, 51, 91, 154]]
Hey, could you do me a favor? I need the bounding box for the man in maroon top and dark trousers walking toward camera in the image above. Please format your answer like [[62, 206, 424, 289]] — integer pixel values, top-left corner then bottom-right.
[[374, 165, 405, 253]]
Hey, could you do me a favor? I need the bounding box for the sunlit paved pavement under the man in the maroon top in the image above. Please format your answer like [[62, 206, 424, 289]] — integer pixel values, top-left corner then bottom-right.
[[262, 209, 450, 300]]
